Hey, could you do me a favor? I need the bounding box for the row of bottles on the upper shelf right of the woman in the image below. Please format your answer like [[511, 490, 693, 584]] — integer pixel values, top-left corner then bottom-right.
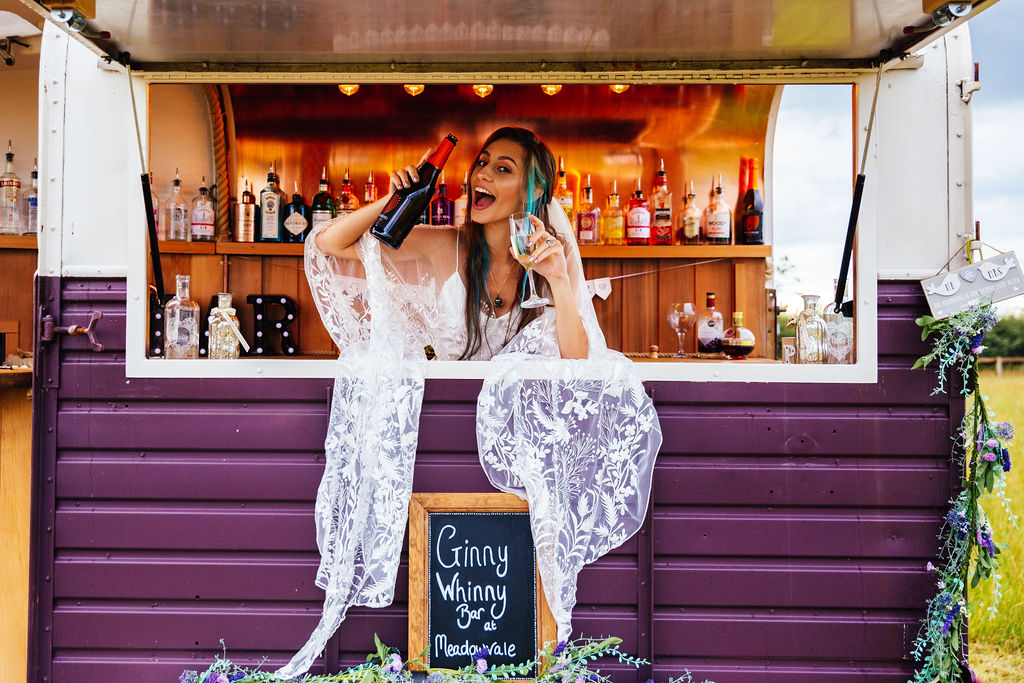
[[569, 157, 764, 247]]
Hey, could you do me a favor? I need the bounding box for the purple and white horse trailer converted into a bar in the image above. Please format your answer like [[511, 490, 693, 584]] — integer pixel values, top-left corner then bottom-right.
[[12, 0, 991, 683]]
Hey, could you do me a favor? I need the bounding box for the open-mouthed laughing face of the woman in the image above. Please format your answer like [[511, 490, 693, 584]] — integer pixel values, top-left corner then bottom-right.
[[469, 139, 525, 224]]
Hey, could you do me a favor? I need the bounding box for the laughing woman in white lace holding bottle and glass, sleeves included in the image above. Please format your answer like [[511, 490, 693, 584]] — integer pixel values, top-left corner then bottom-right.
[[276, 128, 662, 678]]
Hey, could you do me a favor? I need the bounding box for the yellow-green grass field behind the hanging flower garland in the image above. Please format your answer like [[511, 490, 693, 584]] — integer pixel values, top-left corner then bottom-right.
[[970, 373, 1024, 683]]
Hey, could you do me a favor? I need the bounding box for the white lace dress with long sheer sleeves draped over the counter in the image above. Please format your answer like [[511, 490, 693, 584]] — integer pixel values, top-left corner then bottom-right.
[[276, 208, 662, 678]]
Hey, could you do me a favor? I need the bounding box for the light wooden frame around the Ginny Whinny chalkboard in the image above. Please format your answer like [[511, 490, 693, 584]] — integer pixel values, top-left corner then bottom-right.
[[409, 494, 558, 671]]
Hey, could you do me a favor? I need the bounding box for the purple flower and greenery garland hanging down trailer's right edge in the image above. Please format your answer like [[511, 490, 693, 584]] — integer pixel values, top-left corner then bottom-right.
[[912, 304, 1017, 683]]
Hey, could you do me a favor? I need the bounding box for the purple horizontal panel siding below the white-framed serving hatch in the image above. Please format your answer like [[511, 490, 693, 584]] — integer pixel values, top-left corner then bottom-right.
[[32, 280, 963, 683]]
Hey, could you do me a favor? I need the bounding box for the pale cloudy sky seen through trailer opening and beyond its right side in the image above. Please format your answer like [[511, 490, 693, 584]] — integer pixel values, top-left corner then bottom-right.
[[773, 0, 1024, 313]]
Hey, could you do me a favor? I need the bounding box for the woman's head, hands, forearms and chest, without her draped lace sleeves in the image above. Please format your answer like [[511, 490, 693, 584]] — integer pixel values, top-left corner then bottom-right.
[[315, 127, 588, 360]]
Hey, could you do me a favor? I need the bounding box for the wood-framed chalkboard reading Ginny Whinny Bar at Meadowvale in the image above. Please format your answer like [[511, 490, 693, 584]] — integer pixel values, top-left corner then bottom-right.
[[409, 494, 555, 679]]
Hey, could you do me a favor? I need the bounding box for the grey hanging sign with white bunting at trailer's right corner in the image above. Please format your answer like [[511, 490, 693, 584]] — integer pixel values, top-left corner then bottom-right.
[[921, 252, 1024, 319]]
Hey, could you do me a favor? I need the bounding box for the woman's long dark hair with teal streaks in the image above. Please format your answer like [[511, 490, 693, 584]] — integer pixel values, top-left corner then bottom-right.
[[460, 126, 555, 360]]
